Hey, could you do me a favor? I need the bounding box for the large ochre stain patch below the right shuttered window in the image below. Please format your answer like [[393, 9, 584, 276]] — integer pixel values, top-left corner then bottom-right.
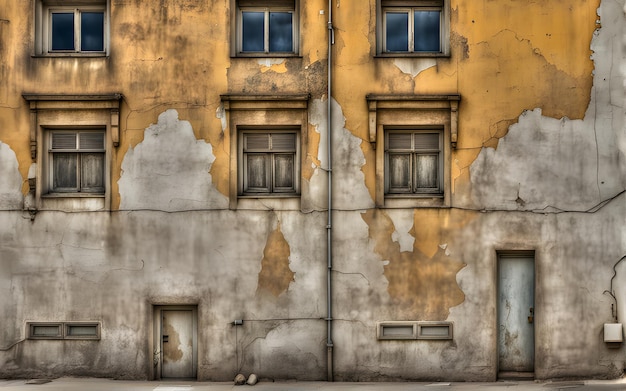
[[361, 209, 466, 320]]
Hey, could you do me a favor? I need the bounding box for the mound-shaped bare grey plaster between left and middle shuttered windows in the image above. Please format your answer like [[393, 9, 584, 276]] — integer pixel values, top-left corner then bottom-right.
[[118, 109, 228, 211]]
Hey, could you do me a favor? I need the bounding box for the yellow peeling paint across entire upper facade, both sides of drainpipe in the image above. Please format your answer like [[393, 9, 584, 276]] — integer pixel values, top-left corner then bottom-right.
[[0, 0, 600, 209]]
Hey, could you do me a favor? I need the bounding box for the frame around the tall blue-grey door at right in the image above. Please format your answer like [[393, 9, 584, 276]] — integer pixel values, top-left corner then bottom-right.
[[494, 250, 538, 379]]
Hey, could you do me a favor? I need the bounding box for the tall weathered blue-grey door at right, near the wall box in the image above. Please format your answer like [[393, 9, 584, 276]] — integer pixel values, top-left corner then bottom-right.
[[498, 255, 535, 372]]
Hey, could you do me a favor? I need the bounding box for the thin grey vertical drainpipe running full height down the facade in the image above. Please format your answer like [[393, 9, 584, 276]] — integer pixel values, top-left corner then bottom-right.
[[326, 0, 335, 381]]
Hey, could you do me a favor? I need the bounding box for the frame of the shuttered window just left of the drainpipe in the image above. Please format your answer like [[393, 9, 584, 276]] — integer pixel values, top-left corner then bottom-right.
[[238, 128, 300, 197]]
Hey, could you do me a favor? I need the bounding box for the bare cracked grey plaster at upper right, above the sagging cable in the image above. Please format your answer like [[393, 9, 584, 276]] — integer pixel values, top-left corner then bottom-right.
[[470, 1, 626, 212]]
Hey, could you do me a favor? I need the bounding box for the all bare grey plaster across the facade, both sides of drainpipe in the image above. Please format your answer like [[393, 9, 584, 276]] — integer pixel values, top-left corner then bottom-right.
[[0, 1, 626, 381]]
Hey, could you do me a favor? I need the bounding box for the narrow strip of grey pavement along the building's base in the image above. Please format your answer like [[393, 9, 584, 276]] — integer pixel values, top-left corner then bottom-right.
[[0, 378, 626, 391]]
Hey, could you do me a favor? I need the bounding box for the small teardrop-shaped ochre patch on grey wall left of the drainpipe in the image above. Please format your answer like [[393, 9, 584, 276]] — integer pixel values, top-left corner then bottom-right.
[[257, 224, 295, 297]]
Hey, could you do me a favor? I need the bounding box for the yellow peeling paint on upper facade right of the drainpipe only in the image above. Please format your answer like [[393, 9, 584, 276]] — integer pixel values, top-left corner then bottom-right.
[[333, 0, 600, 199]]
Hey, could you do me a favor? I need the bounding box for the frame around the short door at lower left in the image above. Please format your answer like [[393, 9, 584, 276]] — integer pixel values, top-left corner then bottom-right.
[[150, 304, 198, 380]]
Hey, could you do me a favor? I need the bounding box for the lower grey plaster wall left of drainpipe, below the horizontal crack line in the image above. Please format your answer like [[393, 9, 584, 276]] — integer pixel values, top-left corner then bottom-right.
[[0, 211, 325, 380]]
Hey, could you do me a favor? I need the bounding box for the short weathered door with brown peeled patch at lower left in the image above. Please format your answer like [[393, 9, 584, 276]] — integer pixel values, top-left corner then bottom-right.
[[161, 309, 195, 378]]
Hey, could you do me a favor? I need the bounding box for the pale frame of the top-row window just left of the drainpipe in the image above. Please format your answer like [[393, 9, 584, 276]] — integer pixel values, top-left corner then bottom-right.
[[231, 0, 300, 57]]
